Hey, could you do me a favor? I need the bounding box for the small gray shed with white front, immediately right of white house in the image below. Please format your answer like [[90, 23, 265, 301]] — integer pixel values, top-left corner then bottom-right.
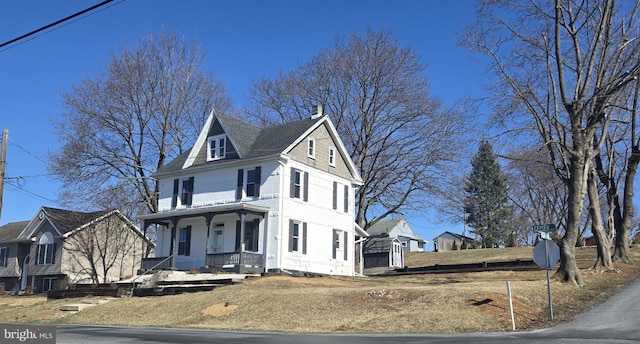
[[363, 236, 404, 269]]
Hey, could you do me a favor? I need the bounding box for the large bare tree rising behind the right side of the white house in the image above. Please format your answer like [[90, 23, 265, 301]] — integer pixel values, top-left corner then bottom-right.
[[247, 29, 468, 228]]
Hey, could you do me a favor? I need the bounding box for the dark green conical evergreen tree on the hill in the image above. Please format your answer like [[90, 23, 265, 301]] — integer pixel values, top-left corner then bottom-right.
[[464, 140, 513, 248]]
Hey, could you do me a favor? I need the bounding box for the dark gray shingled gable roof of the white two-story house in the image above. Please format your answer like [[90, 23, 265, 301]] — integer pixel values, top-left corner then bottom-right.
[[154, 110, 362, 183]]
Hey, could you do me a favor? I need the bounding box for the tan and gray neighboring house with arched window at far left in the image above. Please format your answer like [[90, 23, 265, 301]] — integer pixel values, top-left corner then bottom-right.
[[0, 207, 153, 293]]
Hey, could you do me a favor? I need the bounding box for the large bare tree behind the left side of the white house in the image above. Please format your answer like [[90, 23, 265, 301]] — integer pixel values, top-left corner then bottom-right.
[[49, 30, 232, 212]]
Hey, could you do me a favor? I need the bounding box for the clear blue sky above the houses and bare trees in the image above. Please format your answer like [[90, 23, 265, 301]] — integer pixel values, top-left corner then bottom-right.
[[0, 0, 485, 249]]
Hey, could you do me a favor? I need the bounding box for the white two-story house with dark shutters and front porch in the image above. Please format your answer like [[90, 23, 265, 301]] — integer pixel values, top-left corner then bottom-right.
[[139, 107, 366, 275]]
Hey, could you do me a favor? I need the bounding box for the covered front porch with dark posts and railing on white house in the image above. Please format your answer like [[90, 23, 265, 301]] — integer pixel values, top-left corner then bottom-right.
[[138, 203, 269, 273]]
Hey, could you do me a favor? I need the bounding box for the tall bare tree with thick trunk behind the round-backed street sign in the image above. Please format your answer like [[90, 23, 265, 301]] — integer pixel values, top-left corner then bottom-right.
[[465, 0, 640, 285]]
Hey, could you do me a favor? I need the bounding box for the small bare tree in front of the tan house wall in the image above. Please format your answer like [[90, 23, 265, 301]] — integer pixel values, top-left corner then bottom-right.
[[65, 211, 146, 284]]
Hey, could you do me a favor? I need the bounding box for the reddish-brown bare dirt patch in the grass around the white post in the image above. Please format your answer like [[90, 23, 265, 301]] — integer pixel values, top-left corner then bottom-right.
[[469, 293, 541, 327]]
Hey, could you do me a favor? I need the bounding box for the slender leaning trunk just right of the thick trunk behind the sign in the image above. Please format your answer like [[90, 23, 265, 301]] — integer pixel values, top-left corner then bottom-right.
[[587, 167, 613, 270]]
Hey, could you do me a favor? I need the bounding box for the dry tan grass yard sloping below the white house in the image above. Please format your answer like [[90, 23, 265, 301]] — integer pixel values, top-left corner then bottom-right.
[[0, 248, 640, 333]]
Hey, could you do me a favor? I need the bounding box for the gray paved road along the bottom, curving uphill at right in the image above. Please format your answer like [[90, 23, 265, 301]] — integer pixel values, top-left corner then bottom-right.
[[56, 279, 640, 344]]
